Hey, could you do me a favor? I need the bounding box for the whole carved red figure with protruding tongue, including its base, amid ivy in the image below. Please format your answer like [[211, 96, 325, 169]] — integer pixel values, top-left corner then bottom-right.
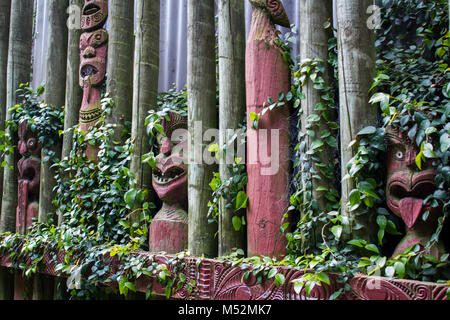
[[386, 129, 445, 257]]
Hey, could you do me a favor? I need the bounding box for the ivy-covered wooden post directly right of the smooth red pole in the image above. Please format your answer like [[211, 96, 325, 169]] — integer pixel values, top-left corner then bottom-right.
[[299, 0, 334, 245]]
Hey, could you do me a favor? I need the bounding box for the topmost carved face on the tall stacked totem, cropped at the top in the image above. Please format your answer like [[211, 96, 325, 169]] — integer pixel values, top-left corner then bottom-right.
[[81, 0, 108, 31]]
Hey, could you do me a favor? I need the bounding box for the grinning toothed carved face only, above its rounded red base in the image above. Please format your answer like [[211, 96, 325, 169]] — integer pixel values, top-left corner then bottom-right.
[[152, 112, 188, 206]]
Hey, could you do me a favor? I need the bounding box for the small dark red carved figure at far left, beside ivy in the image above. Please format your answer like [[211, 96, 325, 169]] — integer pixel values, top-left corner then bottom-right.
[[16, 121, 41, 234]]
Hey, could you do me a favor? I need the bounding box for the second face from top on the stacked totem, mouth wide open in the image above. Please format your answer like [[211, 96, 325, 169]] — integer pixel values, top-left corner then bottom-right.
[[80, 29, 108, 88]]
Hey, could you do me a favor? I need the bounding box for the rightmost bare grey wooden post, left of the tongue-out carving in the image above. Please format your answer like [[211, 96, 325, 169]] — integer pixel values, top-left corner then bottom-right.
[[337, 0, 378, 238]]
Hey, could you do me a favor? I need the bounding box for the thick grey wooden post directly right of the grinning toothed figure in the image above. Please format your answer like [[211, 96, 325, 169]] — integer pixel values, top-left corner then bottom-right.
[[187, 0, 217, 257]]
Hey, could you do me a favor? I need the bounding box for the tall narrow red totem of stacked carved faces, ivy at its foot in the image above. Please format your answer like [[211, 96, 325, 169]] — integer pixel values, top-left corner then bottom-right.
[[80, 0, 108, 160]]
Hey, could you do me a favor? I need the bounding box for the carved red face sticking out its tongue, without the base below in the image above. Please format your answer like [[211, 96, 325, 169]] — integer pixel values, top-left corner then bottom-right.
[[386, 130, 440, 229]]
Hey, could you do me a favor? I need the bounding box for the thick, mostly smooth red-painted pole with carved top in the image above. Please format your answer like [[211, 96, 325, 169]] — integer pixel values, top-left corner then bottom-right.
[[245, 0, 290, 257]]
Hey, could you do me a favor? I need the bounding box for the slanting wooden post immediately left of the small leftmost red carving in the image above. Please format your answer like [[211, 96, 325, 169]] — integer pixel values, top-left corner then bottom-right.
[[0, 0, 33, 299]]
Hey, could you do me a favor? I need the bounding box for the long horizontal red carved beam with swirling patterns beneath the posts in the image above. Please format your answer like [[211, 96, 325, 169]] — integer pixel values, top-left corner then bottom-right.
[[0, 242, 449, 300]]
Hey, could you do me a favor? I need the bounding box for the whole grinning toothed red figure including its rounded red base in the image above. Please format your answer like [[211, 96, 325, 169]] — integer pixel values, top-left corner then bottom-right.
[[149, 112, 188, 254]]
